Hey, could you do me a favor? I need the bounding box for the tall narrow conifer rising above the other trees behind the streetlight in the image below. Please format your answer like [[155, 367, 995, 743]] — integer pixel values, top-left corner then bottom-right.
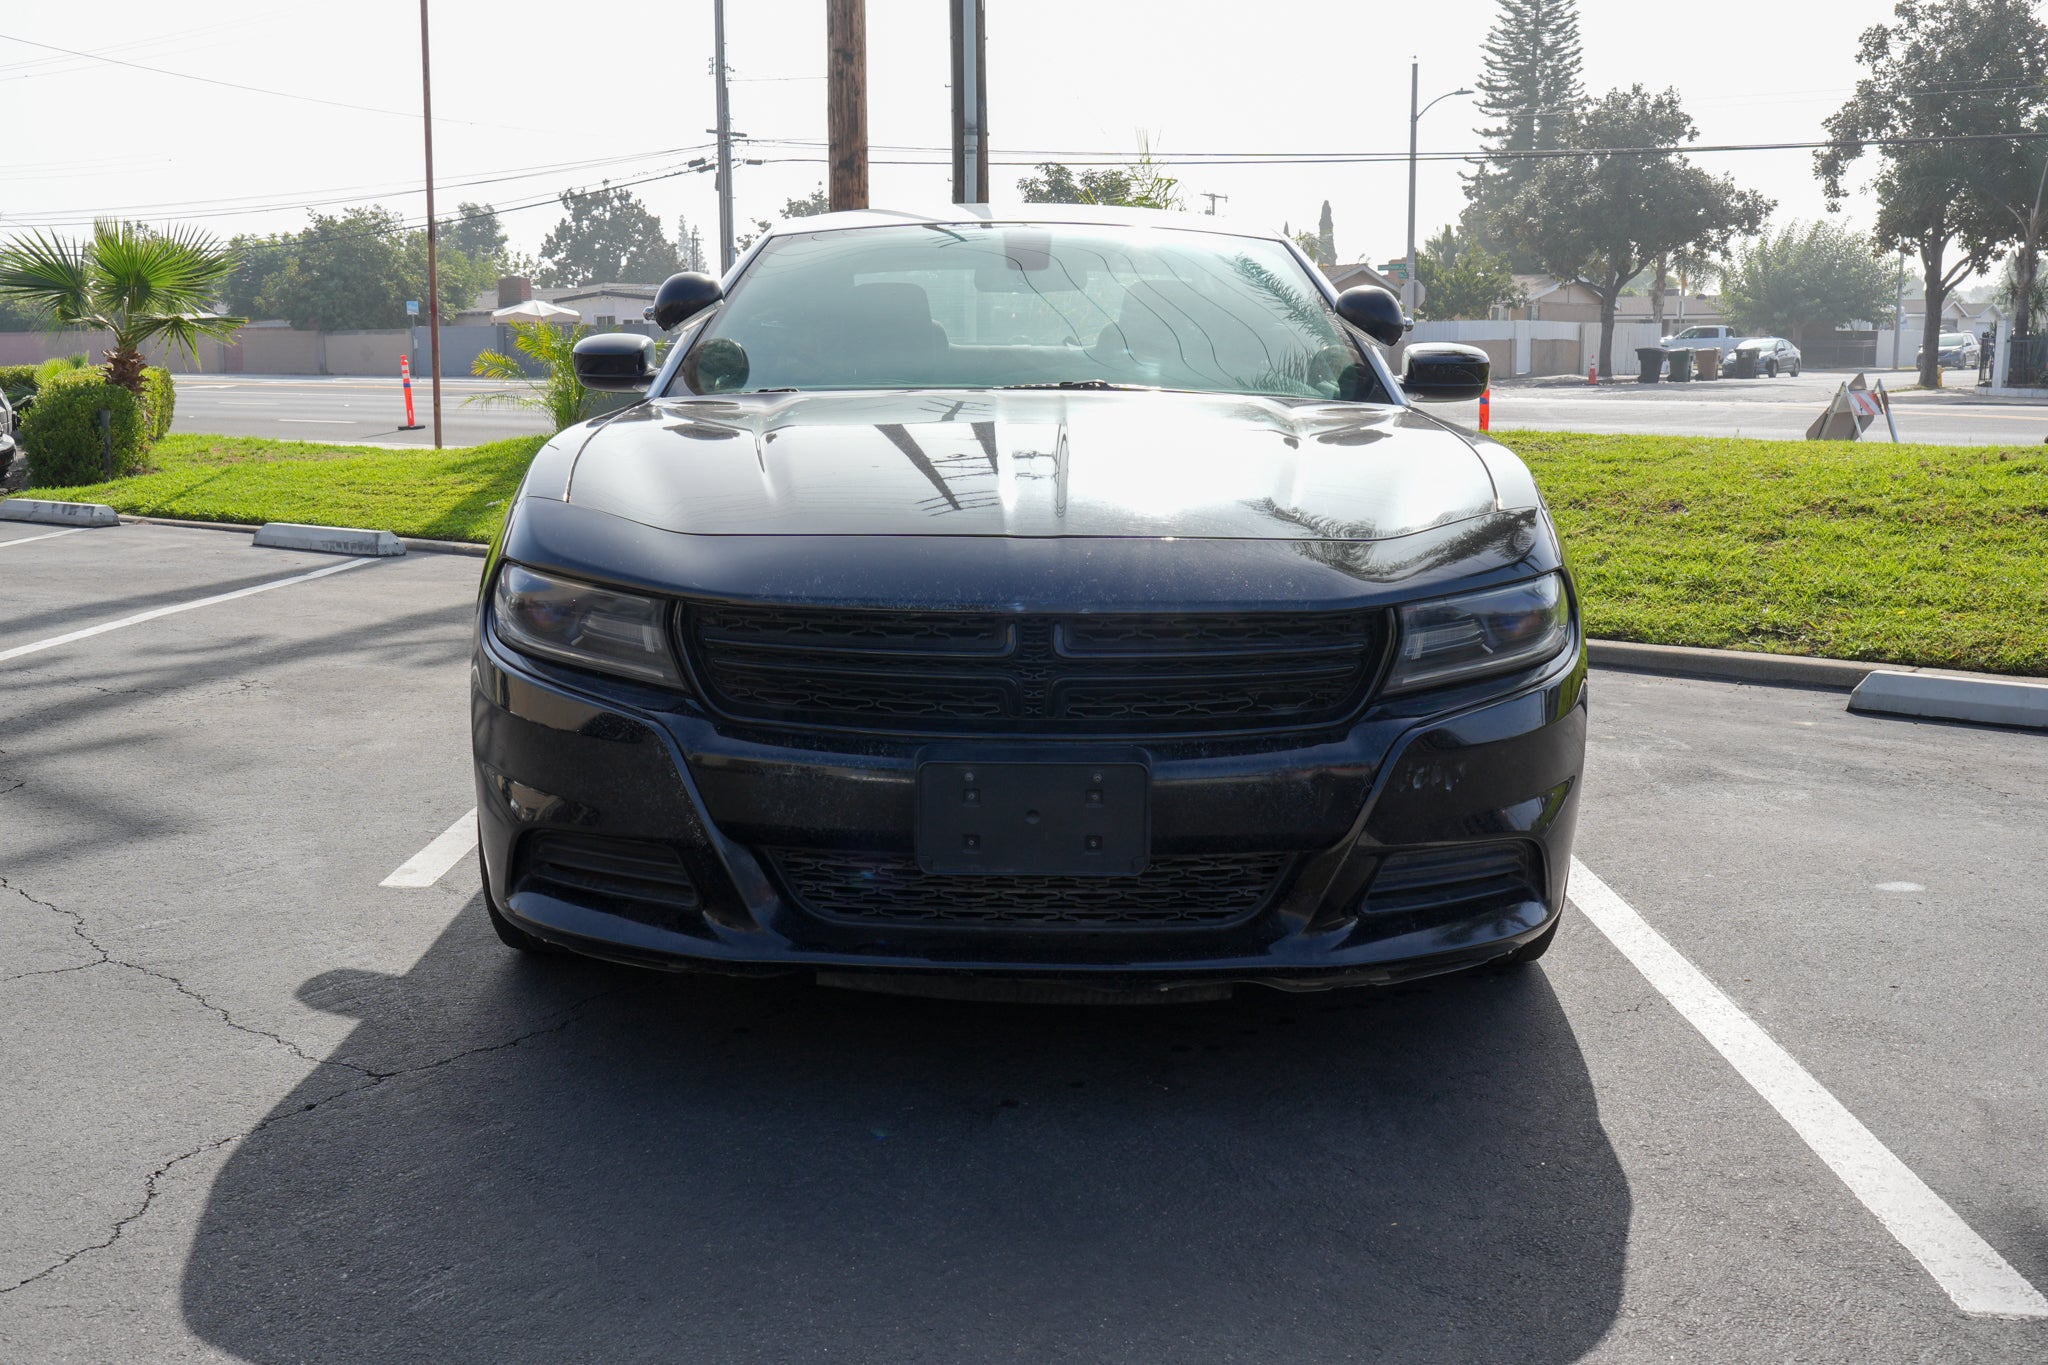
[[1464, 0, 1585, 266]]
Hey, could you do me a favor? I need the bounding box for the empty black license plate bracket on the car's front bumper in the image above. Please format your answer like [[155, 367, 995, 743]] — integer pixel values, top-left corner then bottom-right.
[[915, 759, 1151, 876]]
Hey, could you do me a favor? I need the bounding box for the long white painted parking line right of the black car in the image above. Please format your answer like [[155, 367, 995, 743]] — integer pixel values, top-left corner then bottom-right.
[[1571, 857, 2048, 1318]]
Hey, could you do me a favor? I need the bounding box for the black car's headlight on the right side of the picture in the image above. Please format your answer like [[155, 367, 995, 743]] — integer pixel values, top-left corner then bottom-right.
[[1380, 573, 1571, 694]]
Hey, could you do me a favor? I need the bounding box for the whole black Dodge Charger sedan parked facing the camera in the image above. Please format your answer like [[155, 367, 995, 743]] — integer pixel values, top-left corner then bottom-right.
[[473, 207, 1585, 999]]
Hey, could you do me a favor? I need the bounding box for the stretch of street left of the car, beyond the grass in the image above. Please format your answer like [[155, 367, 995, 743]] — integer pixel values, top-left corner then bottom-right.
[[172, 375, 547, 446]]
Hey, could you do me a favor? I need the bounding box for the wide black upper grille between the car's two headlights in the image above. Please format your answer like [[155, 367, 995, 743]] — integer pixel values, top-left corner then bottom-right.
[[682, 604, 1386, 735]]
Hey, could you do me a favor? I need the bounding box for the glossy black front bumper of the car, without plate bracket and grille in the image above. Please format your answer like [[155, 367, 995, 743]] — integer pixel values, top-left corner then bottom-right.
[[471, 634, 1585, 988]]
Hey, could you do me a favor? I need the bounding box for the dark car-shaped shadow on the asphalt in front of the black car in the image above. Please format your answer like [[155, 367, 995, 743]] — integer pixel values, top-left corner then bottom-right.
[[184, 902, 1630, 1363]]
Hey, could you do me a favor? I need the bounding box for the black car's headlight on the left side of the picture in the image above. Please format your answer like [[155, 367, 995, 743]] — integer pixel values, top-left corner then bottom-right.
[[492, 565, 682, 688]]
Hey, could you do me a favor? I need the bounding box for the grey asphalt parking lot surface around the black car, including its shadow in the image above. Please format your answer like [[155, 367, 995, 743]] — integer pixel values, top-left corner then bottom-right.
[[0, 517, 2048, 1363]]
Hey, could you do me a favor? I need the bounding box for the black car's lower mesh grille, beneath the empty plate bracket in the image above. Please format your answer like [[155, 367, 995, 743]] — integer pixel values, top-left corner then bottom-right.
[[766, 849, 1288, 929]]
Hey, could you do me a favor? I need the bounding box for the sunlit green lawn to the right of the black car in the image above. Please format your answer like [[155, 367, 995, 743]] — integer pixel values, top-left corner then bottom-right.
[[1499, 432, 2048, 673]]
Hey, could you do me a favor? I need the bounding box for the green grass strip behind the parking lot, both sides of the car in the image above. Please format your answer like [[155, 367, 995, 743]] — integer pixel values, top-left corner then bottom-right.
[[16, 432, 2048, 675]]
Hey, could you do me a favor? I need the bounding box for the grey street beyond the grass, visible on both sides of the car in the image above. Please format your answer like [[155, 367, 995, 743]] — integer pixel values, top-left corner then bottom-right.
[[176, 372, 2048, 446]]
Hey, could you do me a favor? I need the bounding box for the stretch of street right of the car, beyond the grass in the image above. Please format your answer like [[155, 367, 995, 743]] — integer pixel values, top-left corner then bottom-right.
[[1432, 370, 2048, 446]]
